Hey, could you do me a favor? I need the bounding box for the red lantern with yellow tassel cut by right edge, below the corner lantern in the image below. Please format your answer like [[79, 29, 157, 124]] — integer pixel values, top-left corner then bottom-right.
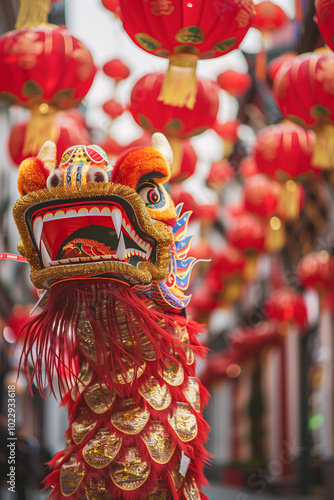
[[273, 49, 334, 168]]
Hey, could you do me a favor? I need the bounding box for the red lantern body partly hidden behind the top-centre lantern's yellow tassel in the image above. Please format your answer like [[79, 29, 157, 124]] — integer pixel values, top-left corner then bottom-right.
[[129, 73, 219, 139]]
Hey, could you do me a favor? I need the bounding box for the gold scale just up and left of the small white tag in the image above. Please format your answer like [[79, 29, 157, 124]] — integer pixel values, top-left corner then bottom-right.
[[142, 422, 176, 464]]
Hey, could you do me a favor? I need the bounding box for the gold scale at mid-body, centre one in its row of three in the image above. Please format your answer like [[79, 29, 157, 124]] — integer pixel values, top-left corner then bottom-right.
[[111, 399, 150, 434]]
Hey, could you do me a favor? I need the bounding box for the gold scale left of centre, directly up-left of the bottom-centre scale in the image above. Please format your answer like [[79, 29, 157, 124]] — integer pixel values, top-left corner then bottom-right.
[[83, 429, 122, 469]]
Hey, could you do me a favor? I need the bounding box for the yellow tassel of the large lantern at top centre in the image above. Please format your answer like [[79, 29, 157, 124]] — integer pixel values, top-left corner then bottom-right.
[[158, 55, 197, 109]]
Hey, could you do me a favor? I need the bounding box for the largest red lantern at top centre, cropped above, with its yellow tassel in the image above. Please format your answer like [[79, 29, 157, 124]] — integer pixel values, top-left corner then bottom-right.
[[119, 0, 254, 109]]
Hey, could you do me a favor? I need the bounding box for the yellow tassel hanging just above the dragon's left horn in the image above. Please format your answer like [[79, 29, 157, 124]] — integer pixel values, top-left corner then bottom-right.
[[22, 104, 57, 156]]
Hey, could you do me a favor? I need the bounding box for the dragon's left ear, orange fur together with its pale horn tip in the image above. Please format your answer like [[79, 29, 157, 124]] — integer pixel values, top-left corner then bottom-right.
[[17, 141, 57, 196]]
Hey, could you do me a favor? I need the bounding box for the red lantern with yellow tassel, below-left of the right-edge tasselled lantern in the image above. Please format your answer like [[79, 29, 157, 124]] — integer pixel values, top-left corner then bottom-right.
[[253, 123, 317, 220]]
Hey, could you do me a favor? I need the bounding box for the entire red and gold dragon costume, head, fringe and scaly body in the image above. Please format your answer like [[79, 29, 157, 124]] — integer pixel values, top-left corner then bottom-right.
[[13, 134, 208, 500]]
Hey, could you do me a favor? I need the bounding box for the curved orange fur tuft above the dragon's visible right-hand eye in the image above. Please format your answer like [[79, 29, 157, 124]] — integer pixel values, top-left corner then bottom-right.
[[112, 146, 170, 189]]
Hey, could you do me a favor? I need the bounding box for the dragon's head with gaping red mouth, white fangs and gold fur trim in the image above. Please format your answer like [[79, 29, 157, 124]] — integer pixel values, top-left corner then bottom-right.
[[13, 133, 195, 309]]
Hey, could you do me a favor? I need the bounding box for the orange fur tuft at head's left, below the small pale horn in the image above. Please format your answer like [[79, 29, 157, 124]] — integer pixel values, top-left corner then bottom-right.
[[17, 157, 49, 196]]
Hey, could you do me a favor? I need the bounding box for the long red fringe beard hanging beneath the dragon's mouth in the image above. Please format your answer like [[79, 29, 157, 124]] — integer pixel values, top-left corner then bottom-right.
[[20, 278, 205, 398]]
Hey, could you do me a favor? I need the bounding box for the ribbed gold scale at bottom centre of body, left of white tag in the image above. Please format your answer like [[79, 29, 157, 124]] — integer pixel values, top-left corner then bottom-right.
[[110, 448, 150, 491]]
